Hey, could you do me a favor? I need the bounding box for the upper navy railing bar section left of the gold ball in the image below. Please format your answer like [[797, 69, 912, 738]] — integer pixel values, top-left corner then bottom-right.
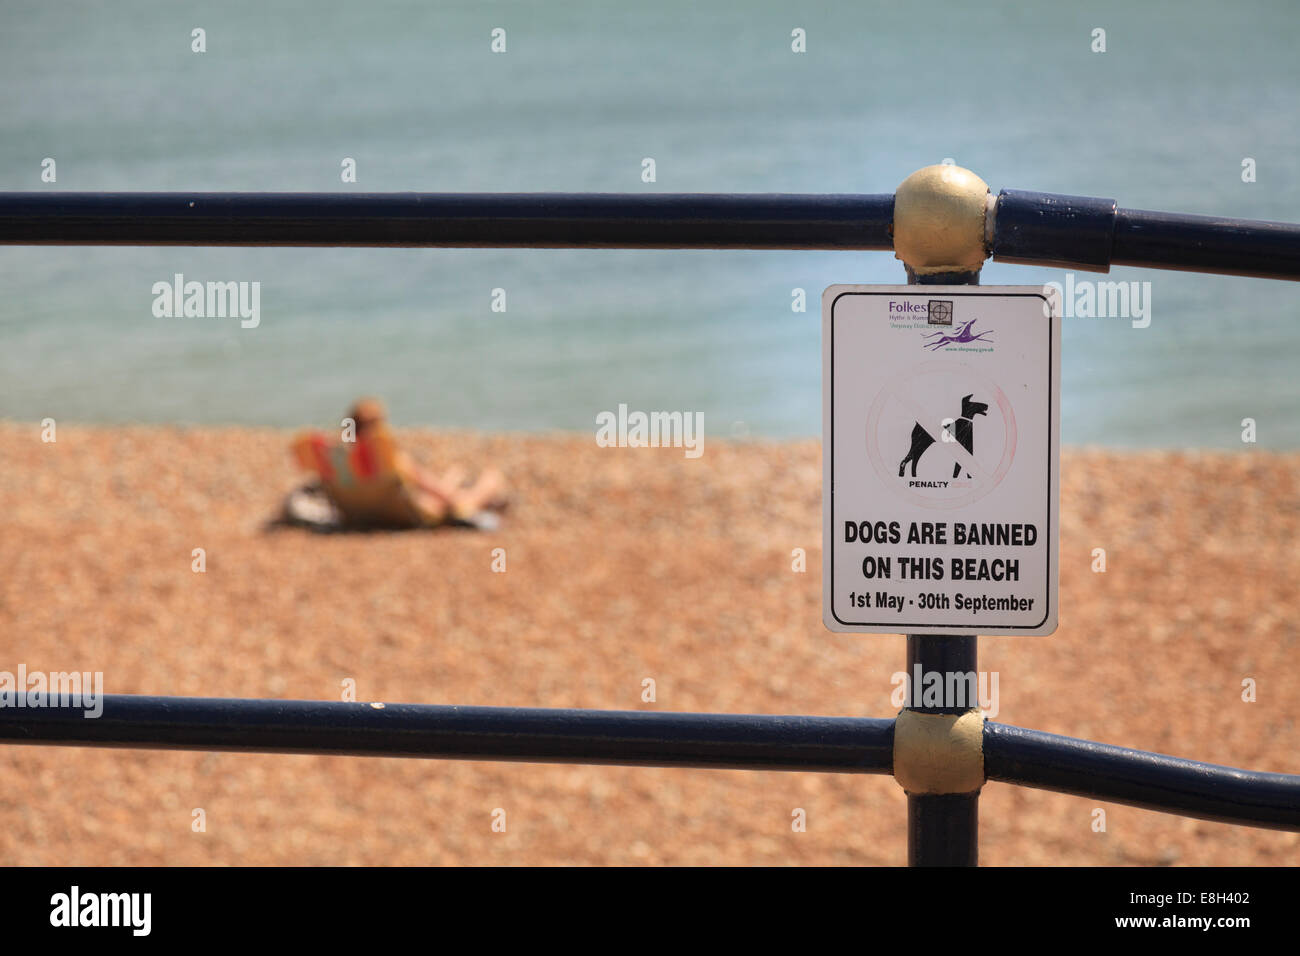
[[0, 193, 893, 250]]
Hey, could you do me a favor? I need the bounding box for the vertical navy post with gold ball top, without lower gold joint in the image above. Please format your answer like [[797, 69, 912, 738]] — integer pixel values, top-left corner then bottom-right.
[[894, 166, 988, 866]]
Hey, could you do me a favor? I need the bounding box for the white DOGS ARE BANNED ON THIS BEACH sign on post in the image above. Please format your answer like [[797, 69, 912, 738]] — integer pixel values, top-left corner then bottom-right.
[[822, 285, 1061, 635]]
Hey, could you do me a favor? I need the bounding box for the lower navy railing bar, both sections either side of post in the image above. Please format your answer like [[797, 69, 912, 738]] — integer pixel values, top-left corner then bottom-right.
[[10, 695, 1300, 830]]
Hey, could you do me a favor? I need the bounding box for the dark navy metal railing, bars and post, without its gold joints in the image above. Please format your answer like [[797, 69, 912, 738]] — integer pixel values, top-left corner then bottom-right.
[[0, 180, 1300, 865]]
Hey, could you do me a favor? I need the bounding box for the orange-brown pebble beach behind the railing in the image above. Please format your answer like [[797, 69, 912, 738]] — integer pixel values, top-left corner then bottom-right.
[[0, 421, 1300, 865]]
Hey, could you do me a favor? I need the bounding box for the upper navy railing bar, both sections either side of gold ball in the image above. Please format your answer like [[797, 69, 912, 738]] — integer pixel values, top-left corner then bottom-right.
[[0, 190, 1300, 280]]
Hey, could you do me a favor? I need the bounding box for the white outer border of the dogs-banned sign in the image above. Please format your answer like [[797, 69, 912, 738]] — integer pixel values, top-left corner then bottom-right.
[[822, 285, 1061, 636]]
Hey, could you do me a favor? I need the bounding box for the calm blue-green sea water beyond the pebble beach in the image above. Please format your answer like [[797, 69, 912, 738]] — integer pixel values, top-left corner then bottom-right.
[[0, 0, 1300, 449]]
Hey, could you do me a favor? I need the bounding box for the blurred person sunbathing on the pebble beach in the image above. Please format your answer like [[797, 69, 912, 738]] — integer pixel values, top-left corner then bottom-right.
[[285, 398, 506, 529]]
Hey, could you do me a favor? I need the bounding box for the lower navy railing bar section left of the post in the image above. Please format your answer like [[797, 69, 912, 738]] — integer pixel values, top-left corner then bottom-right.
[[0, 695, 893, 774]]
